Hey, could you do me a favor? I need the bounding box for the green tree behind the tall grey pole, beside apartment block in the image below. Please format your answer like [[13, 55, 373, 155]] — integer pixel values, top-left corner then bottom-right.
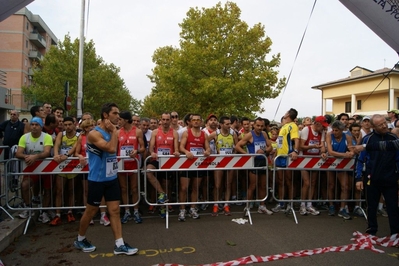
[[23, 35, 141, 116]]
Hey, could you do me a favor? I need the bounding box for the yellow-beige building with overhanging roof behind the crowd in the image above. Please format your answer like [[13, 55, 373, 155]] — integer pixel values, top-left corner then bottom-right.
[[312, 66, 399, 116]]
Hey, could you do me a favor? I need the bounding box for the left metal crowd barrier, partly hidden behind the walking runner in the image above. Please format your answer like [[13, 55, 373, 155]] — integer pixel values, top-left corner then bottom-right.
[[5, 156, 140, 234]]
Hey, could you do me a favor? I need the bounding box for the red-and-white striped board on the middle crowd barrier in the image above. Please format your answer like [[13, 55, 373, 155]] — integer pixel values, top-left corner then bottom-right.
[[159, 156, 254, 170]]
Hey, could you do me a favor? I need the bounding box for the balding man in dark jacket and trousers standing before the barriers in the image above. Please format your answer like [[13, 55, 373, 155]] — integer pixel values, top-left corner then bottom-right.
[[356, 115, 399, 235]]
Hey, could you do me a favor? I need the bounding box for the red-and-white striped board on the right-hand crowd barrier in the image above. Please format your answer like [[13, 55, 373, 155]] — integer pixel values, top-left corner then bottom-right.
[[287, 157, 355, 170]]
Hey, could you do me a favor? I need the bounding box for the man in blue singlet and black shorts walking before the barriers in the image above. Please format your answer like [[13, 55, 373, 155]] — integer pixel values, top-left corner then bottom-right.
[[74, 103, 138, 255]]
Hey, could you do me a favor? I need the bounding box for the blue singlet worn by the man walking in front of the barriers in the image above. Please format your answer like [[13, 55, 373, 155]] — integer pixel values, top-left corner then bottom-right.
[[87, 126, 118, 182]]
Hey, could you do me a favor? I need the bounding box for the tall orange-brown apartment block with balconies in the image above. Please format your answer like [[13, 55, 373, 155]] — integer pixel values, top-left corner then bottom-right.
[[0, 8, 58, 111]]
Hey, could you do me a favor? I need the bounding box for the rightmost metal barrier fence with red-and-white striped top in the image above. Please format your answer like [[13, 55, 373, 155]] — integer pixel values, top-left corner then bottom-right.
[[272, 155, 367, 223]]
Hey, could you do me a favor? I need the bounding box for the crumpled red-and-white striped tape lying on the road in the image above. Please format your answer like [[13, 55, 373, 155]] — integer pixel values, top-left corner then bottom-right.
[[154, 232, 399, 266]]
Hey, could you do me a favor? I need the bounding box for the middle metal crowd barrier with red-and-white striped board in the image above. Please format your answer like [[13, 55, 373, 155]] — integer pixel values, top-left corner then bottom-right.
[[143, 154, 268, 228]]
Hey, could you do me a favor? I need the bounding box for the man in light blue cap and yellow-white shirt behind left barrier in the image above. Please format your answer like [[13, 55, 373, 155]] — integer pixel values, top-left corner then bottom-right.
[[15, 117, 53, 219]]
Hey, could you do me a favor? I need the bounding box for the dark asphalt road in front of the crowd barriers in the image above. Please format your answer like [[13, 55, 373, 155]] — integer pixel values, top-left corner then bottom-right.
[[0, 206, 399, 266]]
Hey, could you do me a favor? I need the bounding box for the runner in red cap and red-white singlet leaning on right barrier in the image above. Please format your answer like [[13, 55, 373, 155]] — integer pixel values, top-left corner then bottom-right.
[[299, 116, 328, 215]]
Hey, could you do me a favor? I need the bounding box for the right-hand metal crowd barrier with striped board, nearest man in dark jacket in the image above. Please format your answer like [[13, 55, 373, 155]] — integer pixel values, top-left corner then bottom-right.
[[272, 155, 367, 224]]
